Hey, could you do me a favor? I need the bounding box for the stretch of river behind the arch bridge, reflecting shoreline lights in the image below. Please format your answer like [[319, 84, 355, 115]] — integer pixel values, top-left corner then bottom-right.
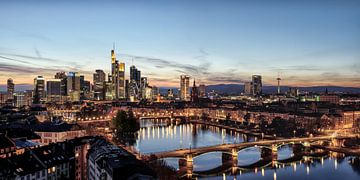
[[135, 121, 255, 154]]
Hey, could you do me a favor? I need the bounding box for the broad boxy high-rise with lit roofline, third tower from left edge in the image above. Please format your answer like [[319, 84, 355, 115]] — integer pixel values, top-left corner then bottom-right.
[[46, 79, 62, 102]]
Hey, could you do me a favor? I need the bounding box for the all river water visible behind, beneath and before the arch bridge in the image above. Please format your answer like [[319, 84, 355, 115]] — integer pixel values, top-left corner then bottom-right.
[[136, 121, 360, 180]]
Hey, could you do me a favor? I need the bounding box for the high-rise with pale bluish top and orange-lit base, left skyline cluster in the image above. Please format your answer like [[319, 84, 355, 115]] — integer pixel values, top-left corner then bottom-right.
[[67, 72, 80, 101]]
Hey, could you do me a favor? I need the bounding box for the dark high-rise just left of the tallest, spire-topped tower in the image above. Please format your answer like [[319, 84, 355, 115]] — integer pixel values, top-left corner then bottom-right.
[[93, 69, 106, 100]]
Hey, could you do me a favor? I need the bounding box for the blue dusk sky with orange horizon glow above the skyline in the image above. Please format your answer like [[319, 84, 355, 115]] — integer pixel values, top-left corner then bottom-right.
[[0, 0, 360, 87]]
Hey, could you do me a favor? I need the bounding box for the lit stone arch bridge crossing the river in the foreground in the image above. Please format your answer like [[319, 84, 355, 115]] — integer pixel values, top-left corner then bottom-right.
[[153, 136, 353, 177]]
